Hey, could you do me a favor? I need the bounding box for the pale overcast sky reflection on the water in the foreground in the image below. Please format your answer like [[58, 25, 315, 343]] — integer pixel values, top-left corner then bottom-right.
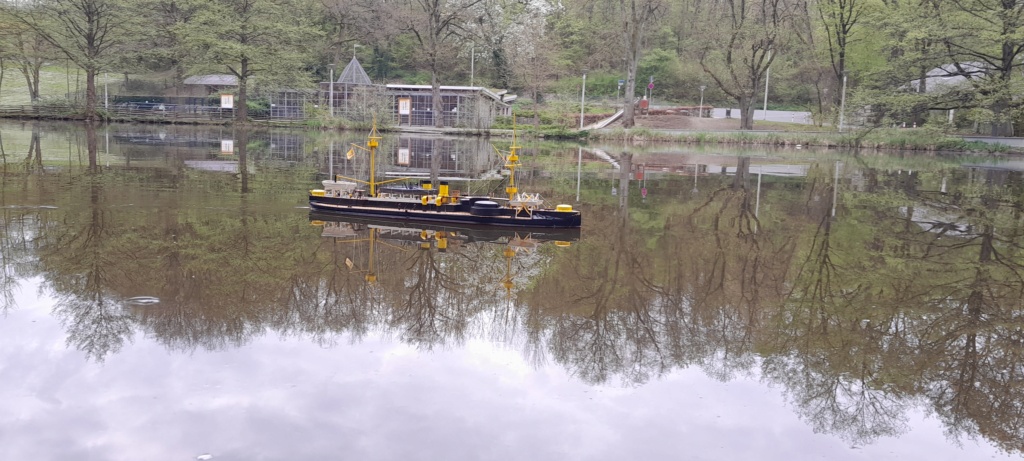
[[0, 281, 1016, 461]]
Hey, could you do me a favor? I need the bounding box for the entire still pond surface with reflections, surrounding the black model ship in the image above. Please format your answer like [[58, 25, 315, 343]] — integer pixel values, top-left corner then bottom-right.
[[0, 122, 1024, 461]]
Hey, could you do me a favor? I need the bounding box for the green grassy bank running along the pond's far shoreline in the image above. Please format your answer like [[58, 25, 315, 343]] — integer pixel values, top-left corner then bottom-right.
[[0, 66, 1024, 154]]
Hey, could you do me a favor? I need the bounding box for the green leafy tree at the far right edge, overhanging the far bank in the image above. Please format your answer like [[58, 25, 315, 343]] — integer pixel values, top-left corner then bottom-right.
[[871, 0, 1024, 135]]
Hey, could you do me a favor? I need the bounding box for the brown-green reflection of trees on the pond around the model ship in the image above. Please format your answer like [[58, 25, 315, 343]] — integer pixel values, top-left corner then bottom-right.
[[0, 126, 1024, 452]]
